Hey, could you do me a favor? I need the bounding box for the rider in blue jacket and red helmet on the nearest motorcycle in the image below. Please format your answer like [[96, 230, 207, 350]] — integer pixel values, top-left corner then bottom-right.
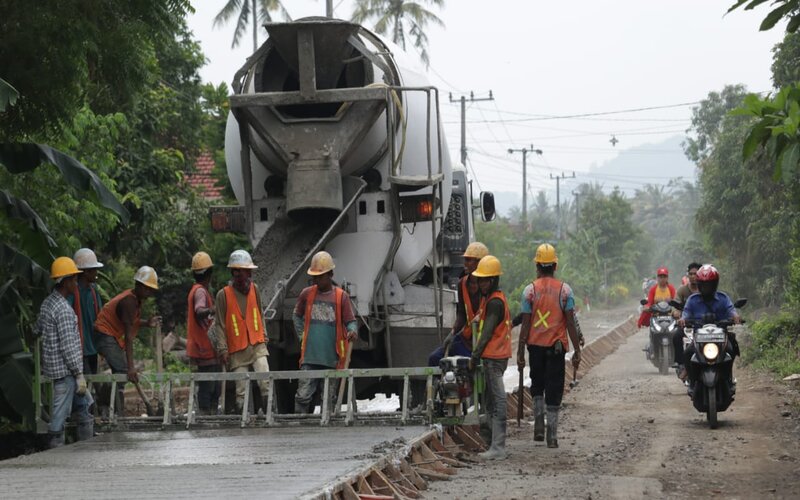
[[678, 264, 741, 394]]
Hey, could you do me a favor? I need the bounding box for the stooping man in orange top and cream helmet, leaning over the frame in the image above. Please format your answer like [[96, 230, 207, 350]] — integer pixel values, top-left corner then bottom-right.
[[94, 266, 161, 412]]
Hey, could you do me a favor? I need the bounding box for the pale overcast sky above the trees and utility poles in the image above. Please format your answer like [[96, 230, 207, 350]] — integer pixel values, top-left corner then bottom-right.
[[189, 0, 783, 197]]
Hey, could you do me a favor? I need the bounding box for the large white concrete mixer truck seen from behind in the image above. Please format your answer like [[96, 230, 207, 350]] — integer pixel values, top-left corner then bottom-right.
[[212, 17, 494, 413]]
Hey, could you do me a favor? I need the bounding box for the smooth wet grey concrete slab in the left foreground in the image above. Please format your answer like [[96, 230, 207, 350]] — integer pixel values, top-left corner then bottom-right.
[[0, 426, 427, 499]]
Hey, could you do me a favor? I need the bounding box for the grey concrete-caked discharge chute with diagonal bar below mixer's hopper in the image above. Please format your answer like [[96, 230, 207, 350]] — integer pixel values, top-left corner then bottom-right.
[[253, 177, 367, 324]]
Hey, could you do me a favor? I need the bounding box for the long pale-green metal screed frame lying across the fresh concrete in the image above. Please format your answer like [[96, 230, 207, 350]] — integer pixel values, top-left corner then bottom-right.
[[86, 367, 440, 429]]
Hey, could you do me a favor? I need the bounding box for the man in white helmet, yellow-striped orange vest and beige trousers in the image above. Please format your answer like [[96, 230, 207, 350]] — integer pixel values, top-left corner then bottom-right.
[[209, 250, 269, 413]]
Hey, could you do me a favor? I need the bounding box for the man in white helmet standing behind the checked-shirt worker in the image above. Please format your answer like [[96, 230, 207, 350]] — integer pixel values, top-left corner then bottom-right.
[[67, 248, 103, 374]]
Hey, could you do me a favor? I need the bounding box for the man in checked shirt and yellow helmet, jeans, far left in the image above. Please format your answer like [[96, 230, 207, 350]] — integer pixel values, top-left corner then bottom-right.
[[36, 257, 94, 448]]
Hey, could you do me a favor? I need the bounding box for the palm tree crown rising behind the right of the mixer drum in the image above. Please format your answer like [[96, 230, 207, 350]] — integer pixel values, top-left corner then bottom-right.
[[352, 0, 444, 66]]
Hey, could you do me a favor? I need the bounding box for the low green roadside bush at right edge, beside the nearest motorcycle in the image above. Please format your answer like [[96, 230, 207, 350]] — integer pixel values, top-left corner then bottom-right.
[[742, 311, 800, 376]]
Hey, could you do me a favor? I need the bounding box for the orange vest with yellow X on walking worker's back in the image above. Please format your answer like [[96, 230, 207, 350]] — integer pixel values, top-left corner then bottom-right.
[[527, 277, 569, 352]]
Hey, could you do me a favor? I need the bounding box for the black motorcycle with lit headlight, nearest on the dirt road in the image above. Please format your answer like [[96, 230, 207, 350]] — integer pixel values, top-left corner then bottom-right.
[[670, 299, 747, 429]]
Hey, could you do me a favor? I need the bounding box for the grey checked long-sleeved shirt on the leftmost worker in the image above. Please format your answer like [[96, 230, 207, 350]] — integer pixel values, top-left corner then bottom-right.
[[36, 290, 83, 380]]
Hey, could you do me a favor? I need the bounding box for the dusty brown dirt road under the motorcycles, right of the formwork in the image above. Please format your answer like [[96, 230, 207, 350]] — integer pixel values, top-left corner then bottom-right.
[[425, 320, 800, 499]]
